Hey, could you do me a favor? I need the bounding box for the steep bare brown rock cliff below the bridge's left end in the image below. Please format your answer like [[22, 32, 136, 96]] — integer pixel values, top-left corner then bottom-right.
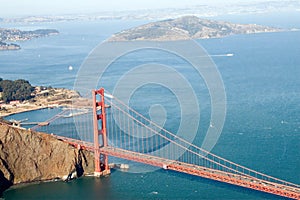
[[0, 122, 94, 196]]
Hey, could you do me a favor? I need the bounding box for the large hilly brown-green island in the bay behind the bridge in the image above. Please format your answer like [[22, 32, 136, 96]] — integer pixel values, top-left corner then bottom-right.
[[108, 16, 281, 41]]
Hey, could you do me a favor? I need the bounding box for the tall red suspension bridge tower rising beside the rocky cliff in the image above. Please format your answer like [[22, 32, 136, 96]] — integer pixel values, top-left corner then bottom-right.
[[92, 88, 110, 176]]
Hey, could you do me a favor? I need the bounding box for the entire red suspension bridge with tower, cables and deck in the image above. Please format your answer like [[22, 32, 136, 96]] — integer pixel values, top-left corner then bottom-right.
[[32, 88, 300, 199]]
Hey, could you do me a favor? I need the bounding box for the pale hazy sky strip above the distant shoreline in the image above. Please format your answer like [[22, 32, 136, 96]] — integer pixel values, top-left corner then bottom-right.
[[0, 0, 272, 18]]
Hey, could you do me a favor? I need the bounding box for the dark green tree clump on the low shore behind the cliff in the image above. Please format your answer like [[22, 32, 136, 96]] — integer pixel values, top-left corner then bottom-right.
[[0, 78, 34, 103]]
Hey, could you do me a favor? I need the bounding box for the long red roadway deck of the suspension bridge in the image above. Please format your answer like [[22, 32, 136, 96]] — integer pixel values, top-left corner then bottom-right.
[[55, 136, 300, 199]]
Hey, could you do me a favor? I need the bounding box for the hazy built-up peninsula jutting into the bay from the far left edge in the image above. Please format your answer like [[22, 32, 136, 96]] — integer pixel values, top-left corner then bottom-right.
[[0, 28, 59, 50]]
